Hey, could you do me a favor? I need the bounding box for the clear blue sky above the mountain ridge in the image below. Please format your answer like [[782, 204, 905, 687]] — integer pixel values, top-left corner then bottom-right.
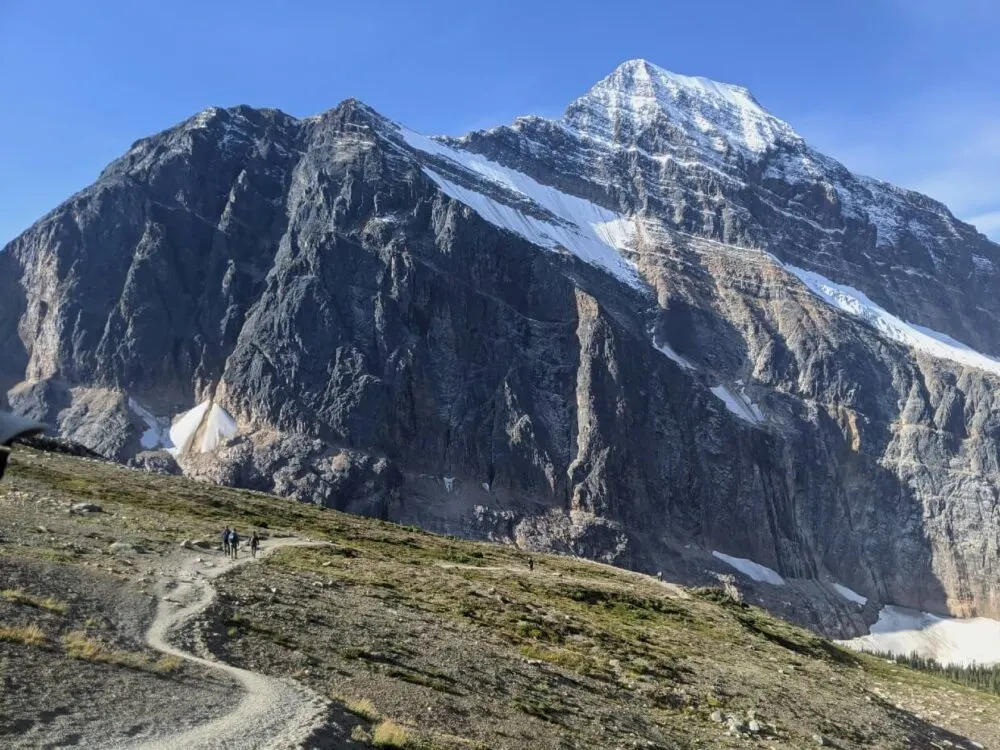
[[0, 0, 1000, 245]]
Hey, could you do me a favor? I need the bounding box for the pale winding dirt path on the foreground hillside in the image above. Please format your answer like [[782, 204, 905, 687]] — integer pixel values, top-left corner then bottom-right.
[[117, 539, 330, 750]]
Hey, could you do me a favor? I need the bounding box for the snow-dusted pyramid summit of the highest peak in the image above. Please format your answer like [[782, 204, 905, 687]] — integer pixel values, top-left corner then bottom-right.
[[562, 60, 802, 158]]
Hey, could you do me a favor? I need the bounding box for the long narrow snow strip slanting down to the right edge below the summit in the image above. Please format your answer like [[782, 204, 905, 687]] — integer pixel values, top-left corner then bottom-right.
[[784, 264, 1000, 375]]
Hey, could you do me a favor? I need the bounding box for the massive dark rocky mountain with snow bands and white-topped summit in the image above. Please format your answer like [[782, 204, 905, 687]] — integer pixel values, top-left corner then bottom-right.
[[0, 60, 1000, 636]]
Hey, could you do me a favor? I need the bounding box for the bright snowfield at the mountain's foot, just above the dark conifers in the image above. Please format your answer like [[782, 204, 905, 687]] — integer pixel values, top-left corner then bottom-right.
[[838, 605, 1000, 666]]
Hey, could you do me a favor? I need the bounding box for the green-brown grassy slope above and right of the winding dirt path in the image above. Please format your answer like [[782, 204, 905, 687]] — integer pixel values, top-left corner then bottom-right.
[[0, 451, 1000, 748]]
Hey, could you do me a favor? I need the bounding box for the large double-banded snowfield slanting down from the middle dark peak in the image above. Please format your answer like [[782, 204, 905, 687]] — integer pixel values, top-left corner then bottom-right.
[[400, 128, 644, 289]]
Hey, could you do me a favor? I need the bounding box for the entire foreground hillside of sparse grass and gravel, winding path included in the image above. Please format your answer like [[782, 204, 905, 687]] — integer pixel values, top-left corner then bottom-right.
[[0, 451, 1000, 750]]
